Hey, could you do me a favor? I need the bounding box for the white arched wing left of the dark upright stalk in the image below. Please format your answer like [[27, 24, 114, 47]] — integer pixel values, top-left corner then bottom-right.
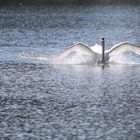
[[53, 43, 98, 64]]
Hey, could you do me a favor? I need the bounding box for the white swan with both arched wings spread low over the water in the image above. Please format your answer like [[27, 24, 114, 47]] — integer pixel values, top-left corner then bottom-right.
[[52, 42, 140, 65]]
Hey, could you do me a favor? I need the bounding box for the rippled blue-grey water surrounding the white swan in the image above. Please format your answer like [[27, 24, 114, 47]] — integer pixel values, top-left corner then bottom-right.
[[0, 5, 140, 140]]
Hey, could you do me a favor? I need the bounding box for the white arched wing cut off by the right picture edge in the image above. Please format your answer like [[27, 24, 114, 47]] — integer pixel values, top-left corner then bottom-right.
[[106, 42, 140, 64]]
